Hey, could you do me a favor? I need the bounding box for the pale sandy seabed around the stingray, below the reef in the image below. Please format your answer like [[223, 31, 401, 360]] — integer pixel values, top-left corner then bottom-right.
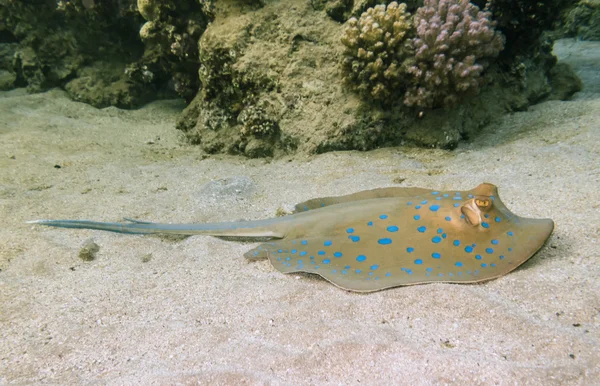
[[0, 41, 600, 385]]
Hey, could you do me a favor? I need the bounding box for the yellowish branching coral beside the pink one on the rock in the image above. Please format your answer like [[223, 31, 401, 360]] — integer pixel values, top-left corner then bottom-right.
[[342, 2, 411, 100]]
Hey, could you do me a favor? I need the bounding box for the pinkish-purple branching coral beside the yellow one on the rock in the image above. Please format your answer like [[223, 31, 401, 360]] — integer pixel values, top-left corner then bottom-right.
[[404, 0, 504, 107]]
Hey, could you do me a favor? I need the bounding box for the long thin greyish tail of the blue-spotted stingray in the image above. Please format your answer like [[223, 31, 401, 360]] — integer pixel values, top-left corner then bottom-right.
[[27, 218, 283, 238]]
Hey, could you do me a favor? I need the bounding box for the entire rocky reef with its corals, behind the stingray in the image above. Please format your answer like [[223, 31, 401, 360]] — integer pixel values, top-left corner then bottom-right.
[[0, 0, 584, 157]]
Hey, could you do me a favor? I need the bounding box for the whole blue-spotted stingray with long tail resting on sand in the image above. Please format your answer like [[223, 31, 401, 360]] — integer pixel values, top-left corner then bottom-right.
[[32, 183, 554, 292]]
